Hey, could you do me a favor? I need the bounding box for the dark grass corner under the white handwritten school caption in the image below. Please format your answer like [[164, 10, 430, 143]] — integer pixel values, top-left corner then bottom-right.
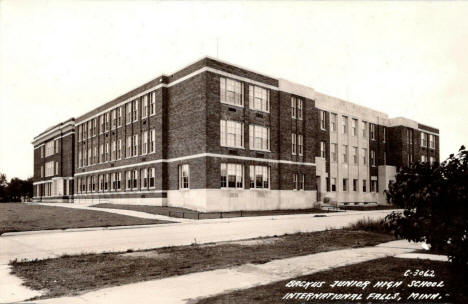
[[191, 257, 468, 304]]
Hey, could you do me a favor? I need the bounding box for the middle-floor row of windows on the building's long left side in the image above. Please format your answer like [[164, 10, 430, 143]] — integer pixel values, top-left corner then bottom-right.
[[78, 129, 156, 168]]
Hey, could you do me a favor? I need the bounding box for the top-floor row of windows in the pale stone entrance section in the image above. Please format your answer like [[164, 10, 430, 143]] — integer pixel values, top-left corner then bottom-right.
[[320, 111, 387, 142]]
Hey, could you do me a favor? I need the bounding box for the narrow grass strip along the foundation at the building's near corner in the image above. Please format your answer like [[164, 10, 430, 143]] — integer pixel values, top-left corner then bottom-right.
[[91, 203, 330, 220]]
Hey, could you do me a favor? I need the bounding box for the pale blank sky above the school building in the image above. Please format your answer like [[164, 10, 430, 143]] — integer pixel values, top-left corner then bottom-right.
[[0, 0, 468, 179]]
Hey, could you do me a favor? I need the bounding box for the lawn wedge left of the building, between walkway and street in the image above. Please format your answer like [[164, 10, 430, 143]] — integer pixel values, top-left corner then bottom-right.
[[0, 203, 174, 234]]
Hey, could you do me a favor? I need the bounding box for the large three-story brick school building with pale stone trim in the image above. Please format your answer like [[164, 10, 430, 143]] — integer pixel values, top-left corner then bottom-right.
[[34, 58, 439, 211]]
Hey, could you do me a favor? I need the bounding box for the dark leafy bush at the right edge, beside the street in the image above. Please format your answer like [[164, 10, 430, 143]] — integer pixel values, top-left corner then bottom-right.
[[386, 146, 468, 267]]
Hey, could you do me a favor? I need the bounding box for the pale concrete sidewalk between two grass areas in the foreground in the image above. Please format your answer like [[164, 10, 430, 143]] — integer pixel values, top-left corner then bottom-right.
[[34, 241, 421, 304]]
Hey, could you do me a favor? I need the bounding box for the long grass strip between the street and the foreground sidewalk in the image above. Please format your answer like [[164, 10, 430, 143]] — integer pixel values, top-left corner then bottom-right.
[[11, 230, 394, 297]]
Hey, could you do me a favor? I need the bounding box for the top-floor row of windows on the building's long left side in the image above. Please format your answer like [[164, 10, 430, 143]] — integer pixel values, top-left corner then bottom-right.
[[77, 92, 156, 141]]
